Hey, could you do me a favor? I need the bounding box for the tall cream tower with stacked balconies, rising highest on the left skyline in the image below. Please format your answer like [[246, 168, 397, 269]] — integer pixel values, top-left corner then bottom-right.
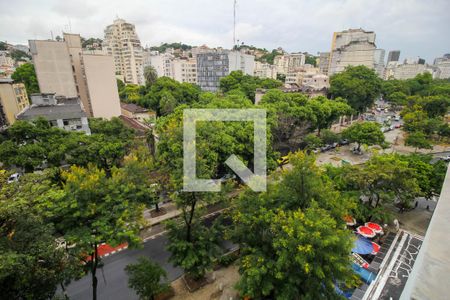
[[102, 19, 145, 85]]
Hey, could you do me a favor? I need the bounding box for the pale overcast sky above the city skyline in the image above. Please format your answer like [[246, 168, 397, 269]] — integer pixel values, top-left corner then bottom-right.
[[0, 0, 450, 62]]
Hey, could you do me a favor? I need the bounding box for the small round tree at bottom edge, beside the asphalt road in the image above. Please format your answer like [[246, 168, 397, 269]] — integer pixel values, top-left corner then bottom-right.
[[125, 256, 169, 300]]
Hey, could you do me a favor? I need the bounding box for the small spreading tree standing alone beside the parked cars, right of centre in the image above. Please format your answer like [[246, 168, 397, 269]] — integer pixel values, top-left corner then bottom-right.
[[342, 122, 385, 151]]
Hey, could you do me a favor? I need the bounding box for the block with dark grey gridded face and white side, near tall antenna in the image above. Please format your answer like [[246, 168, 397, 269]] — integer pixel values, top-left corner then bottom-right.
[[197, 51, 255, 92]]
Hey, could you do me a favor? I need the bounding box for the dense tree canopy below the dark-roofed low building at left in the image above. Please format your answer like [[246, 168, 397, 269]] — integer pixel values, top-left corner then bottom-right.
[[0, 118, 134, 172]]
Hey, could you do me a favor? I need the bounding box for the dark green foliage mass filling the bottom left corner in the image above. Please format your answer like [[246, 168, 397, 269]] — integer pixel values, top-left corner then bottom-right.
[[0, 170, 82, 299]]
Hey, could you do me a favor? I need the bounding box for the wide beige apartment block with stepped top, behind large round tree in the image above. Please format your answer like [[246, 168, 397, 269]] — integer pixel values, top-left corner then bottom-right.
[[328, 29, 376, 76]]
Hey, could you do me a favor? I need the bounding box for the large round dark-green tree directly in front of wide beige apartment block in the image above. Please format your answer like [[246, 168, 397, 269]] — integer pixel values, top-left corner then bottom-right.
[[330, 66, 382, 113]]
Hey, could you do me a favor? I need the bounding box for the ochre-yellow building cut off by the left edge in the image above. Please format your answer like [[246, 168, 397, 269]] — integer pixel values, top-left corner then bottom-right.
[[0, 78, 30, 128]]
